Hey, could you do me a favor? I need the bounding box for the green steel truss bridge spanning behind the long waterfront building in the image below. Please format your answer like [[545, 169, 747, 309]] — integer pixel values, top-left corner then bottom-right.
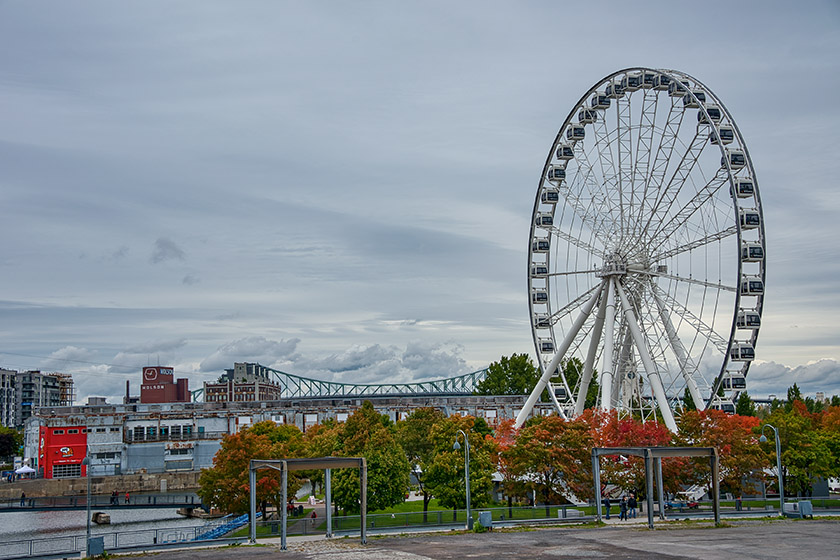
[[192, 364, 487, 401]]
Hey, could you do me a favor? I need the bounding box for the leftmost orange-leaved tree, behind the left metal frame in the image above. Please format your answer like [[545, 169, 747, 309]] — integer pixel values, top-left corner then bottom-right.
[[198, 421, 302, 513]]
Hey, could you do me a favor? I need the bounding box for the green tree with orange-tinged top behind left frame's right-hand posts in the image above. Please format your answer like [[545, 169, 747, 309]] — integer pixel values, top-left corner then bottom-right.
[[333, 401, 410, 513]]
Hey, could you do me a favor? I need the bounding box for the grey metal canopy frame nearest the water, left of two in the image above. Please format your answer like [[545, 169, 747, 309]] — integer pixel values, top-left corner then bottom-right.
[[248, 457, 367, 550]]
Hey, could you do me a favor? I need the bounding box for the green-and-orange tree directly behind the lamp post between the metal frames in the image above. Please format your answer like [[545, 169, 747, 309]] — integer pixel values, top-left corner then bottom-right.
[[426, 416, 495, 519]]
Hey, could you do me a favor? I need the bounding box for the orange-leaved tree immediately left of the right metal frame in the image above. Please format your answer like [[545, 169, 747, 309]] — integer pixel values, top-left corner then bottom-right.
[[505, 415, 593, 509]]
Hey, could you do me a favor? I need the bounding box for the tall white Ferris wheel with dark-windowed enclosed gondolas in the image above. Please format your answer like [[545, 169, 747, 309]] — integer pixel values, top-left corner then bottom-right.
[[516, 68, 766, 431]]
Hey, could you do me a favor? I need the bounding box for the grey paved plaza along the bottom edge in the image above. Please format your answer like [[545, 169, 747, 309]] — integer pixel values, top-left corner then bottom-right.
[[124, 519, 840, 560]]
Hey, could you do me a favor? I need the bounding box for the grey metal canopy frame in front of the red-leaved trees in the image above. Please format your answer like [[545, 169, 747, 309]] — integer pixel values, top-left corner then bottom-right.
[[592, 447, 720, 529]]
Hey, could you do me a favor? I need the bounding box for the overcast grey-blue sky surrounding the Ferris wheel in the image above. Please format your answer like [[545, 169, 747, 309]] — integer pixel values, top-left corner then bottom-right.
[[0, 0, 840, 402]]
